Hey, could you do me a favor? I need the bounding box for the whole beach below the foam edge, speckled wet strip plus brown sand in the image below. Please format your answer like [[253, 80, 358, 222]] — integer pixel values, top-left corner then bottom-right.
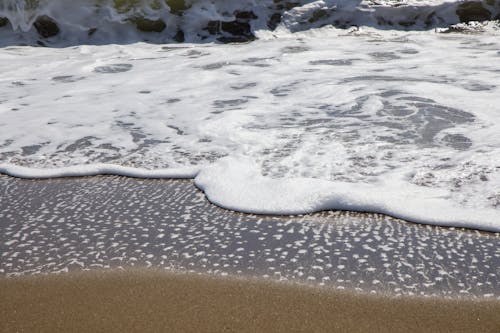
[[0, 176, 500, 332]]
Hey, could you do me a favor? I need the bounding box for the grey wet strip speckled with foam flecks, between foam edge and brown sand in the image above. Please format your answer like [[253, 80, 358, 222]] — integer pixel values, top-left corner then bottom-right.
[[0, 176, 500, 299]]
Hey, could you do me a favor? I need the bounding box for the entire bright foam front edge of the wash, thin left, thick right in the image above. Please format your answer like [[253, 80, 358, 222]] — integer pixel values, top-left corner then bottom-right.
[[0, 157, 500, 232]]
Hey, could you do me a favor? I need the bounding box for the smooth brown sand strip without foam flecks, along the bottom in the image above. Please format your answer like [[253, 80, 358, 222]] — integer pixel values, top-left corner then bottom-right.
[[0, 270, 500, 332]]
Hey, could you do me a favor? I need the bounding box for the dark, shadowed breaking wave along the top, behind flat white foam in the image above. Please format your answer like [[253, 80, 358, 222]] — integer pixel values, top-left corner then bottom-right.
[[0, 0, 500, 45]]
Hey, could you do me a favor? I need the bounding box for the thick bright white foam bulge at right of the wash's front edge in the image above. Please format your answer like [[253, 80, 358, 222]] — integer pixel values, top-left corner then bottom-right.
[[195, 158, 500, 232]]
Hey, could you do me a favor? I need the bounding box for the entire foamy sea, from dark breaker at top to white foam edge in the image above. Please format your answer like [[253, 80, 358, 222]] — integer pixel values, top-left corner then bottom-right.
[[0, 0, 500, 232]]
